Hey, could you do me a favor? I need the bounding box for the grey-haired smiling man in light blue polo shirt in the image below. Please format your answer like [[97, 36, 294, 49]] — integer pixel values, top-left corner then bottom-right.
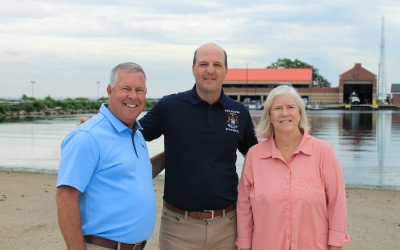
[[56, 63, 156, 250]]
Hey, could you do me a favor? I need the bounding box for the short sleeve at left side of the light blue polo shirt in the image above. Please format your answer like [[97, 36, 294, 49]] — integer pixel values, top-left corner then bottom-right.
[[57, 131, 100, 193]]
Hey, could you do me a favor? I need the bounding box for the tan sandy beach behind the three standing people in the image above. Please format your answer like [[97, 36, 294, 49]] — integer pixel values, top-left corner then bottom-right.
[[0, 172, 400, 250]]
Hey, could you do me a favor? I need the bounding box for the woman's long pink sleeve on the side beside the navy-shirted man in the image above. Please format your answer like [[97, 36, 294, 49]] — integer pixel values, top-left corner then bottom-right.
[[235, 150, 254, 248]]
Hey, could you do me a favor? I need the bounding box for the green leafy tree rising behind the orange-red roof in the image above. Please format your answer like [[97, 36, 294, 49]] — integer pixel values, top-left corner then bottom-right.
[[267, 58, 331, 87]]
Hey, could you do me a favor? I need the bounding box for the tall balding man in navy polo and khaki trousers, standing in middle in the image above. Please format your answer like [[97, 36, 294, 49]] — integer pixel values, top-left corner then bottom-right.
[[140, 44, 257, 250]]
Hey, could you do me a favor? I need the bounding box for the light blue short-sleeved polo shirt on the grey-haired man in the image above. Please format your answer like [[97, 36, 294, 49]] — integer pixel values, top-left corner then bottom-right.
[[57, 104, 156, 244]]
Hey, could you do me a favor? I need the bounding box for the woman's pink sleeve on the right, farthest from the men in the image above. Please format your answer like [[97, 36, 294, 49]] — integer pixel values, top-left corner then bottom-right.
[[323, 145, 350, 247]]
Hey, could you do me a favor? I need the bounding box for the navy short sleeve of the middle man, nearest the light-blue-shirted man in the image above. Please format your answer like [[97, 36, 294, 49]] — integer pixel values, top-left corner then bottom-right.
[[139, 98, 164, 141]]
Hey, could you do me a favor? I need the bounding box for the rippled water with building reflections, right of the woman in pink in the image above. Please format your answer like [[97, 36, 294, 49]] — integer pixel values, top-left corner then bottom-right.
[[308, 111, 400, 189]]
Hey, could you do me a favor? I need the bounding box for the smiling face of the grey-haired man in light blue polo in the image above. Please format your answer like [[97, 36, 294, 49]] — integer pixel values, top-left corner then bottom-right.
[[107, 70, 147, 128]]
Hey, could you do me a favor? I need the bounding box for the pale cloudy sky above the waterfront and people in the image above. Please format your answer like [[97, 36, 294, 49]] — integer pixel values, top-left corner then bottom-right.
[[0, 0, 400, 98]]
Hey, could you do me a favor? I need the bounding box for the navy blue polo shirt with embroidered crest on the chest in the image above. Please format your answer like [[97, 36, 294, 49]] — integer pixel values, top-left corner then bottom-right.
[[140, 85, 257, 211]]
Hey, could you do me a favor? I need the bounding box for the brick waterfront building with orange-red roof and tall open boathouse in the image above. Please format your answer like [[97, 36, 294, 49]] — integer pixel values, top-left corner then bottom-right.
[[222, 63, 376, 104]]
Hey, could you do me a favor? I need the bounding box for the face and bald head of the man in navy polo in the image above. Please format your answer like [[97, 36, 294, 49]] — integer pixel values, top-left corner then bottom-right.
[[192, 44, 227, 95]]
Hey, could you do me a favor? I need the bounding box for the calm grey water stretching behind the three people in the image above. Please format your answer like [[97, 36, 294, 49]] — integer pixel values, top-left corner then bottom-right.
[[0, 110, 400, 190]]
